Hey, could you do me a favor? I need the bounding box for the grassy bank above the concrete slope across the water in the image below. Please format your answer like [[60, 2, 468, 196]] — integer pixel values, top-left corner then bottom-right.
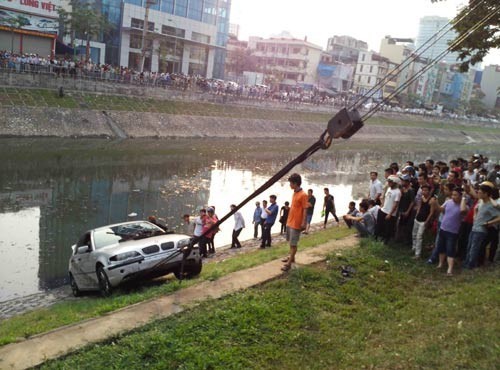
[[0, 87, 500, 132]]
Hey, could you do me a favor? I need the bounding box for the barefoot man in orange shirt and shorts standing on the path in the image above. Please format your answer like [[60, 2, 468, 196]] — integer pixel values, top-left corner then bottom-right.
[[281, 173, 311, 271]]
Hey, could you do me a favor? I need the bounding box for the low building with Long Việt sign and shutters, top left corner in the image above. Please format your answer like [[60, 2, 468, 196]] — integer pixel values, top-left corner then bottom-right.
[[0, 0, 69, 57]]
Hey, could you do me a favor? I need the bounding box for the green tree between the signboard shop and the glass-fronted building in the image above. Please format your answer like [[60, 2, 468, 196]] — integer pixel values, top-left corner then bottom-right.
[[57, 0, 113, 60]]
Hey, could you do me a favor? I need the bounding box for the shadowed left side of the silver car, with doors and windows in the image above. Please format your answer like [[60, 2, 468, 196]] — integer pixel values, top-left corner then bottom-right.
[[71, 232, 97, 289]]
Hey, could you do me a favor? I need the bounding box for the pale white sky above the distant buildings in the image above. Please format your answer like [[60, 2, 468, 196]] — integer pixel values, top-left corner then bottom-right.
[[230, 0, 500, 66]]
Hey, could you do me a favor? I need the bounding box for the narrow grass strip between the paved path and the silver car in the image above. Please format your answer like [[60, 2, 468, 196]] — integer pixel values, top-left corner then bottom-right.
[[0, 228, 352, 345]]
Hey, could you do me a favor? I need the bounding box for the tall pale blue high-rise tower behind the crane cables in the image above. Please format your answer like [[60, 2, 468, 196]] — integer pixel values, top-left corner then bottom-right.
[[417, 16, 458, 64]]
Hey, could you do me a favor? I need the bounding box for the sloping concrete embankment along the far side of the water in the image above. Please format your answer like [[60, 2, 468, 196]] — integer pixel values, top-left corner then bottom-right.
[[0, 107, 500, 144]]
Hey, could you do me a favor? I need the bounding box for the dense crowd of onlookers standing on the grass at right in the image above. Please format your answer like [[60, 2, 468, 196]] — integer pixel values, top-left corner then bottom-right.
[[344, 154, 500, 276]]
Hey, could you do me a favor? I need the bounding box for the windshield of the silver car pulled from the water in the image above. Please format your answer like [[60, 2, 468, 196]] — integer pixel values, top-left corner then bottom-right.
[[94, 222, 165, 249]]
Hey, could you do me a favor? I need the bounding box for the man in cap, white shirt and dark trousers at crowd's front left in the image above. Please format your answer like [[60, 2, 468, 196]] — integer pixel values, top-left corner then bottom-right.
[[375, 175, 401, 243]]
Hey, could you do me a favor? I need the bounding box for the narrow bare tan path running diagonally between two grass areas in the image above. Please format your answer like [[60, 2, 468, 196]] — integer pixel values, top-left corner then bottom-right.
[[0, 236, 358, 369]]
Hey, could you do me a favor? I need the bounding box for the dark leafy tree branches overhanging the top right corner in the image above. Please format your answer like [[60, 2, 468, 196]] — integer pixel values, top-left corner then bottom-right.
[[432, 0, 500, 72]]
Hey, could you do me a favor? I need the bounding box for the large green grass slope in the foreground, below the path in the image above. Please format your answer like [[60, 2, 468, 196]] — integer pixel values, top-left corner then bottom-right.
[[38, 241, 500, 369]]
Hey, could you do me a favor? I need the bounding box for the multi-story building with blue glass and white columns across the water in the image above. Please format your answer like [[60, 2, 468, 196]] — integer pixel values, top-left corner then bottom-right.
[[76, 0, 231, 78]]
